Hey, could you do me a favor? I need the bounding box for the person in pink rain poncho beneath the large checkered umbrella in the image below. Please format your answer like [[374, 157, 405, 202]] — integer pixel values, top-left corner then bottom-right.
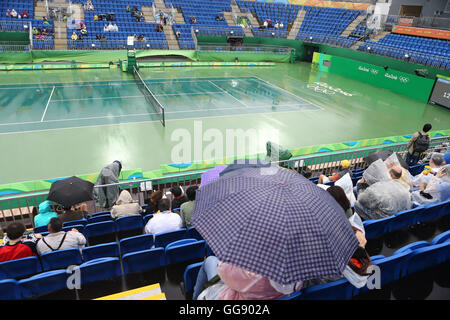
[[193, 256, 303, 300]]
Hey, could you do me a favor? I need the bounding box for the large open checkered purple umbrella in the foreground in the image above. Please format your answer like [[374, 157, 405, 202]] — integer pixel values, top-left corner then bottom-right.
[[192, 167, 358, 284]]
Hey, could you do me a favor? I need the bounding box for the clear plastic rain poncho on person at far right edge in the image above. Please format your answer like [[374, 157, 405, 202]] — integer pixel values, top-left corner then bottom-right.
[[411, 164, 450, 205]]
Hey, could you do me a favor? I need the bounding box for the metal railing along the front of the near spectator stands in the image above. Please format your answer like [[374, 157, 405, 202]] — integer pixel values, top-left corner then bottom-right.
[[0, 136, 450, 227]]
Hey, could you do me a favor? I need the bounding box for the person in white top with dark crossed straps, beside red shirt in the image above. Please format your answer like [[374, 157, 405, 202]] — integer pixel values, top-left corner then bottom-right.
[[36, 218, 86, 255]]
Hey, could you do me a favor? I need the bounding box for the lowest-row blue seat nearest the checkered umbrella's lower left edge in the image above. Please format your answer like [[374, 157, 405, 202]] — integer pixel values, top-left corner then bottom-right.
[[165, 239, 206, 265]]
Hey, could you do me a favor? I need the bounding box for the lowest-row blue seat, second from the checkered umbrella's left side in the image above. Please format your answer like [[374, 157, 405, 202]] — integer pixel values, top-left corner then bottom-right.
[[122, 248, 164, 274]]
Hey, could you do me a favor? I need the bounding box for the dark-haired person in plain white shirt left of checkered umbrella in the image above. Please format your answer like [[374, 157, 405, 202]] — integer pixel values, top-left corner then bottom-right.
[[145, 198, 182, 236]]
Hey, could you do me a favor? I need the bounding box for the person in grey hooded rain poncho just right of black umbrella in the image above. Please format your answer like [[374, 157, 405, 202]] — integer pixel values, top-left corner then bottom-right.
[[94, 160, 122, 208]]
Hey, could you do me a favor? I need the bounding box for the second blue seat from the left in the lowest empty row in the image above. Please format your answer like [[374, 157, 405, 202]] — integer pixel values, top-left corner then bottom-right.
[[19, 270, 70, 298]]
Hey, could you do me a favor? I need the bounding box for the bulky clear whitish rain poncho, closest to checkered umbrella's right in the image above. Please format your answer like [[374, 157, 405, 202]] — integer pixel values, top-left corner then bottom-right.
[[355, 159, 412, 220]]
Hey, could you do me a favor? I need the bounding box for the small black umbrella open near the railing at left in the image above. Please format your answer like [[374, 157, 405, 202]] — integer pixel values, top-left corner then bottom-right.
[[47, 176, 94, 208]]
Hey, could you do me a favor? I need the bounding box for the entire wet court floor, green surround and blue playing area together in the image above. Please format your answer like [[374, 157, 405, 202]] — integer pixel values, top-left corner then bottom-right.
[[0, 63, 450, 183]]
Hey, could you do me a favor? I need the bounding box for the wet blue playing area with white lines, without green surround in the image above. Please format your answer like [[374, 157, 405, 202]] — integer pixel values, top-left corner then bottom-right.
[[0, 77, 320, 133]]
